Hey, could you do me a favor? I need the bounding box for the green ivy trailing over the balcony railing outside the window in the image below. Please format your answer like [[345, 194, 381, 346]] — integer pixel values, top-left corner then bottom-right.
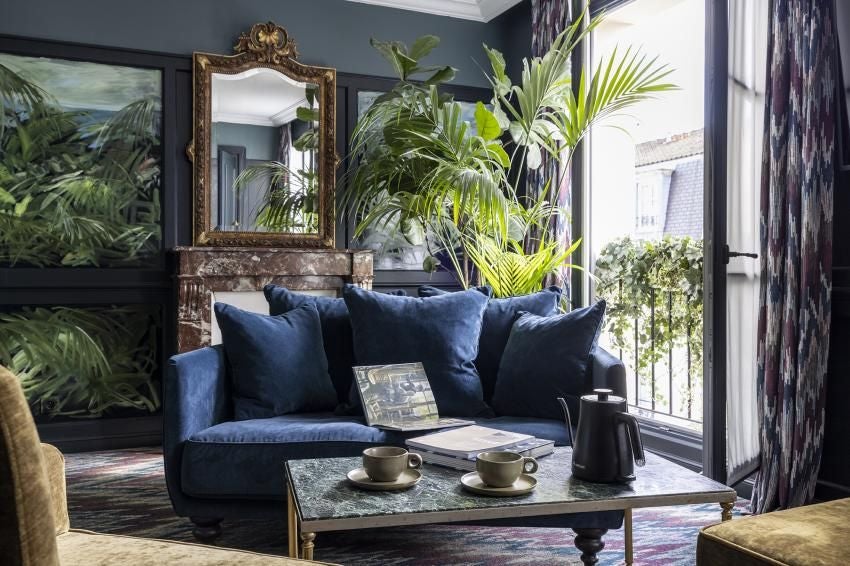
[[593, 236, 703, 412]]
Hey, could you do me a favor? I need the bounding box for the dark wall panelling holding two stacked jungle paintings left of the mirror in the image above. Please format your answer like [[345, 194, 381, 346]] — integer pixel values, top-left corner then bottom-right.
[[0, 35, 192, 450]]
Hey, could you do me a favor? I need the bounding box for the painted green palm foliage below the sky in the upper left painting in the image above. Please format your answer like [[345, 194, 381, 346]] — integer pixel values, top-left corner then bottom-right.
[[0, 65, 160, 267]]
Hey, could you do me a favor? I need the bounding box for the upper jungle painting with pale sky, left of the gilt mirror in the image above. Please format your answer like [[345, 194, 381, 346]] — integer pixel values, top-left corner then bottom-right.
[[0, 53, 162, 267]]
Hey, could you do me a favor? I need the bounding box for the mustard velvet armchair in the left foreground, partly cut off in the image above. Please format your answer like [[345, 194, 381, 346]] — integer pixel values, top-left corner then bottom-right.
[[0, 366, 332, 566]]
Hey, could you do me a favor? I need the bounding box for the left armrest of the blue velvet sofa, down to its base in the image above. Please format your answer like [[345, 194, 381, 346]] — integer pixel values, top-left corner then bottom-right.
[[162, 346, 231, 514]]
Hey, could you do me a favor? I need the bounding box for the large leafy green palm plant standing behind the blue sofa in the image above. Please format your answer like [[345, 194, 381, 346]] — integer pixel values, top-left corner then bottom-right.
[[342, 13, 675, 296]]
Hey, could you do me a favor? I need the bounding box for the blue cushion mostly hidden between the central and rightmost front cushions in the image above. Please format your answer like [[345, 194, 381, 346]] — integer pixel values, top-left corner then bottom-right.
[[419, 285, 561, 401]]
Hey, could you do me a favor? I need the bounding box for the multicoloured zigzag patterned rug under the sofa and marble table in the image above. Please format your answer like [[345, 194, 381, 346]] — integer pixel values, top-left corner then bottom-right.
[[66, 448, 746, 566]]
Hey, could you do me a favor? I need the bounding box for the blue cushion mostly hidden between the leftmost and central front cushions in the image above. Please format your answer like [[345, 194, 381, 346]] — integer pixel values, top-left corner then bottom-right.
[[263, 285, 404, 403]]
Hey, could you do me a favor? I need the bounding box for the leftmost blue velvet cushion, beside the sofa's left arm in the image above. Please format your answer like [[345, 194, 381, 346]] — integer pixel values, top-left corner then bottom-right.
[[214, 303, 336, 420]]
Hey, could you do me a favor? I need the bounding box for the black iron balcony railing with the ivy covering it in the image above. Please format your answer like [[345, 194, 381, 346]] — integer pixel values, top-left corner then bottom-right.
[[594, 237, 702, 430]]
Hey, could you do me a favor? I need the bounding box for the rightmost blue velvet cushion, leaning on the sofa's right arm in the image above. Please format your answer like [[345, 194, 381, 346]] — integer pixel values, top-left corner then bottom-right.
[[491, 301, 605, 419]]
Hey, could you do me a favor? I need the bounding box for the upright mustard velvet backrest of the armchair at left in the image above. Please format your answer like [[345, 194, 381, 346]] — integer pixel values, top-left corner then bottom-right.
[[0, 366, 60, 566]]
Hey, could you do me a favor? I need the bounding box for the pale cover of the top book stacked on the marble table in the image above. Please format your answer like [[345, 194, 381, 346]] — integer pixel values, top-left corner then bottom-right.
[[407, 425, 534, 458]]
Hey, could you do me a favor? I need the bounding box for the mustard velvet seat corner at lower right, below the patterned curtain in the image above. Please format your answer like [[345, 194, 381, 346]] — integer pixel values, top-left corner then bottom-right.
[[697, 498, 850, 566]]
